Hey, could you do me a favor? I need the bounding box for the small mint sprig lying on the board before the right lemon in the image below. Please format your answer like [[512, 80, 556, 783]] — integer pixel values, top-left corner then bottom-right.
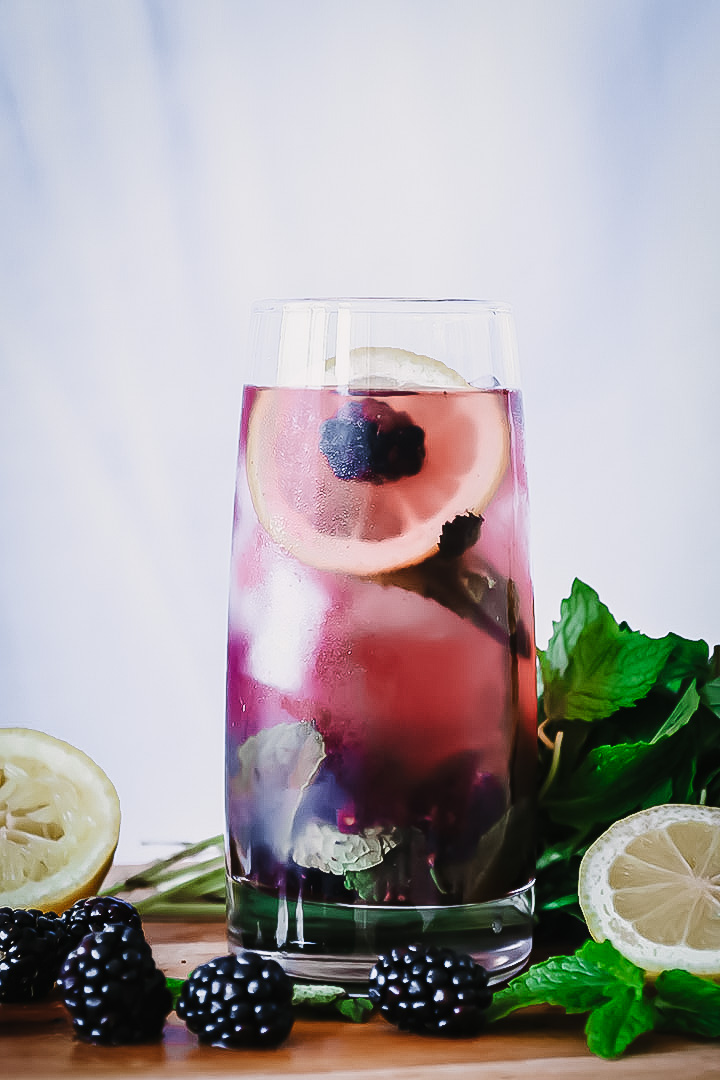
[[488, 941, 720, 1058]]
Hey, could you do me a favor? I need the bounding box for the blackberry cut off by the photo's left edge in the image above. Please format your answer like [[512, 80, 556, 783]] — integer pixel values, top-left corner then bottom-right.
[[0, 907, 67, 1002]]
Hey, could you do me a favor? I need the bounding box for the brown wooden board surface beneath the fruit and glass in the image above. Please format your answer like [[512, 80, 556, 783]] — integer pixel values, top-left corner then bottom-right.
[[0, 922, 720, 1080]]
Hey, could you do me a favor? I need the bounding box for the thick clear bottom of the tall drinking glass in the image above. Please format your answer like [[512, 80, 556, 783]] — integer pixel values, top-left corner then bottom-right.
[[228, 879, 534, 986]]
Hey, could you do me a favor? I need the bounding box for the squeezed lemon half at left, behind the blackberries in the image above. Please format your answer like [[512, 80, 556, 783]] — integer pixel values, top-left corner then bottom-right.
[[0, 728, 120, 913]]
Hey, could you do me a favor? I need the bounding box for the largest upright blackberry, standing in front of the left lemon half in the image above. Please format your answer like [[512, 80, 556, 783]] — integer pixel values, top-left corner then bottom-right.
[[57, 923, 173, 1045]]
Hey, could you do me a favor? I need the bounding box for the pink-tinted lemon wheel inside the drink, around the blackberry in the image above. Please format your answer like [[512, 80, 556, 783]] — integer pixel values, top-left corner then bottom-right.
[[246, 349, 510, 577]]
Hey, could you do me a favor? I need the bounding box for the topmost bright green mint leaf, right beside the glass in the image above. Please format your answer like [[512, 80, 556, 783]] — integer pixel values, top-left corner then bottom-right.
[[540, 579, 678, 720]]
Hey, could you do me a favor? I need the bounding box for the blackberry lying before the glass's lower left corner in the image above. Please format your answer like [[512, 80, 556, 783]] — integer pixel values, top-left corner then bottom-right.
[[176, 953, 295, 1047]]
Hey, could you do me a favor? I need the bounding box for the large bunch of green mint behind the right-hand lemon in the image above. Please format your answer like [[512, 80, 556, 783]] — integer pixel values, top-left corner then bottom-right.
[[536, 580, 720, 935]]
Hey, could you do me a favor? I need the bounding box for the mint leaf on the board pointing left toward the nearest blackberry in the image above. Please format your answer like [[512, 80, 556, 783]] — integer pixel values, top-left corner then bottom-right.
[[488, 941, 643, 1021]]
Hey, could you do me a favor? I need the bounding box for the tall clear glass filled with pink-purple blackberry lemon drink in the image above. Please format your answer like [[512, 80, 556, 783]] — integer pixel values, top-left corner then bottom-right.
[[227, 299, 536, 983]]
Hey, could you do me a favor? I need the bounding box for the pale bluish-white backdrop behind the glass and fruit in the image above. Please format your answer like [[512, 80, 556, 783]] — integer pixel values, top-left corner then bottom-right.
[[0, 0, 720, 861]]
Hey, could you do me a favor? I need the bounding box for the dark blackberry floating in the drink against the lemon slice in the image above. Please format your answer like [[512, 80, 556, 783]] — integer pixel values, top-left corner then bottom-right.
[[320, 397, 425, 484]]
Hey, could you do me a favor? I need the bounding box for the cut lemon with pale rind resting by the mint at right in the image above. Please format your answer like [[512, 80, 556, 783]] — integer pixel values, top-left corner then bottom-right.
[[578, 804, 720, 977]]
